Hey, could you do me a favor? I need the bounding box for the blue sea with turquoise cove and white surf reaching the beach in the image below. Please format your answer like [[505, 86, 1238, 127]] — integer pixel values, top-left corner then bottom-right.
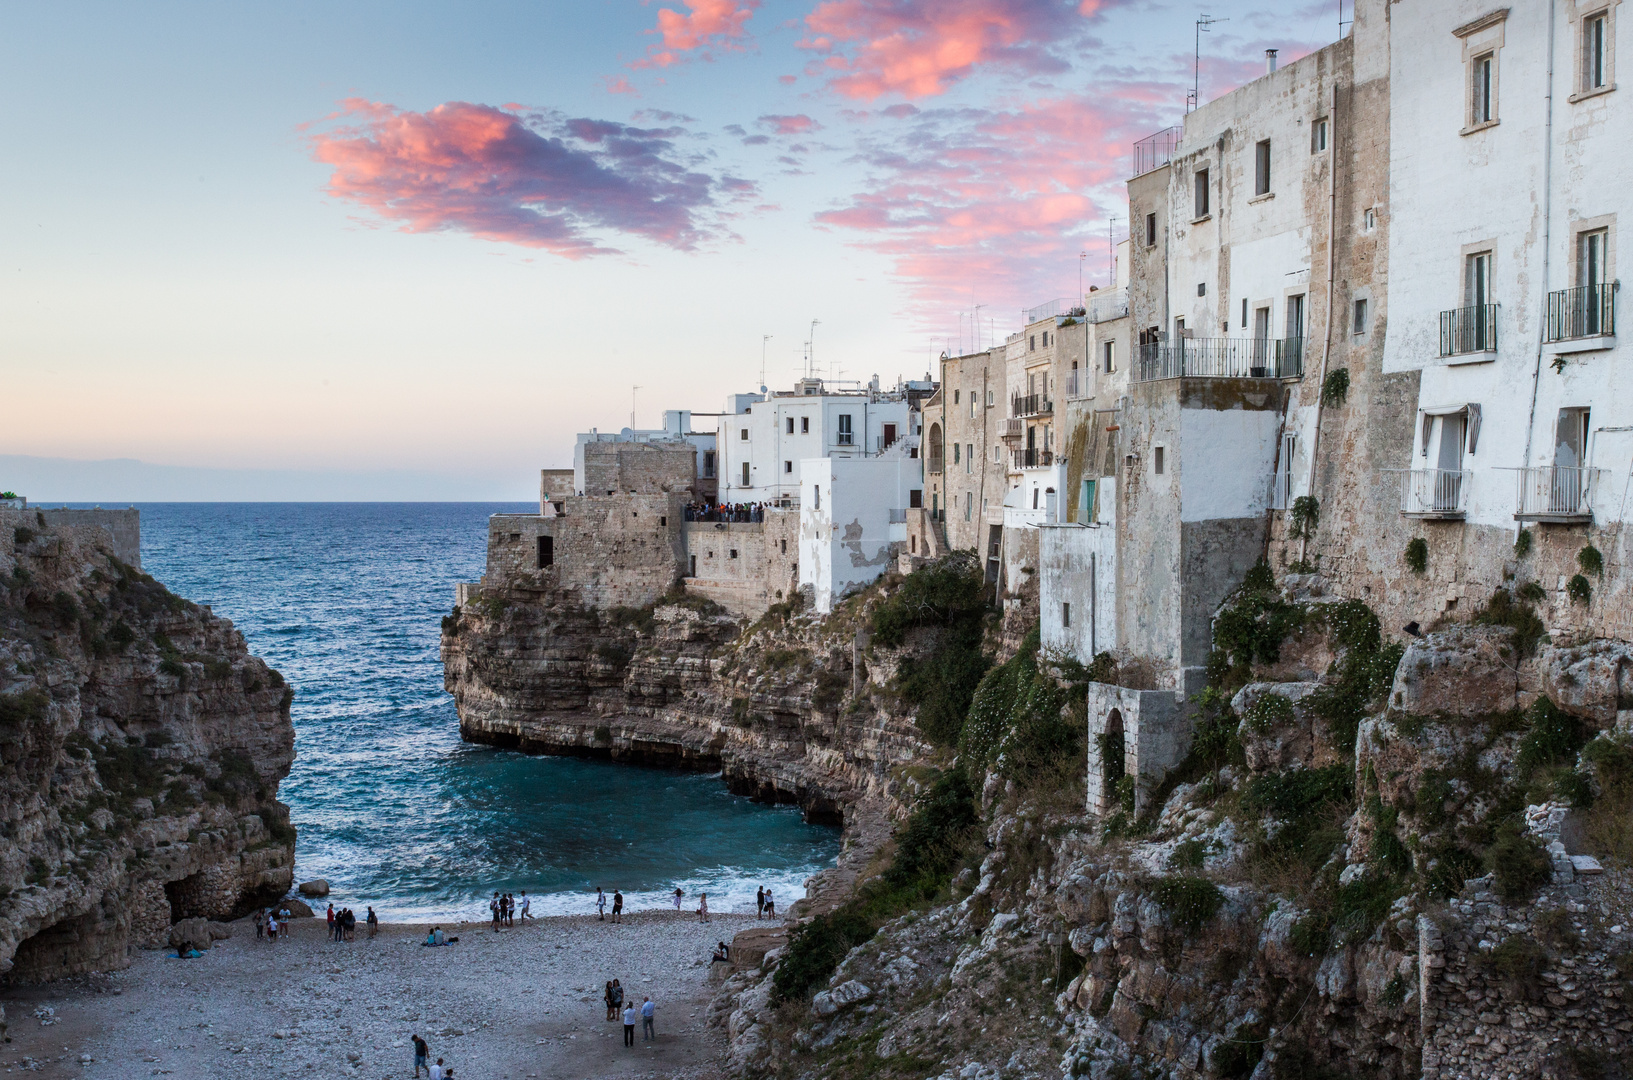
[[110, 503, 839, 922]]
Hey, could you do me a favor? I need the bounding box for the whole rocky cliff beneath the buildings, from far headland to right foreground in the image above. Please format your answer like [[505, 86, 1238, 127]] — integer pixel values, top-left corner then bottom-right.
[[444, 558, 1633, 1080]]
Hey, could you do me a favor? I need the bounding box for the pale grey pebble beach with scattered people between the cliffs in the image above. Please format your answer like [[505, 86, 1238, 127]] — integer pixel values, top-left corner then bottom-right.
[[0, 910, 751, 1080]]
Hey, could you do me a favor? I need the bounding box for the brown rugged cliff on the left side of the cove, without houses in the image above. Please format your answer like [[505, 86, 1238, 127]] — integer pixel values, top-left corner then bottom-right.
[[0, 511, 294, 982]]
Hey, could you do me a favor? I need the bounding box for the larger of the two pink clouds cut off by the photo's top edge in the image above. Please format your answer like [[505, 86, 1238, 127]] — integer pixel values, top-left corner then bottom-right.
[[800, 0, 1109, 101]]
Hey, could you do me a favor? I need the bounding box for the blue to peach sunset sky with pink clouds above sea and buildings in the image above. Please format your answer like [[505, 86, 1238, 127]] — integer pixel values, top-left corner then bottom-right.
[[0, 0, 1339, 502]]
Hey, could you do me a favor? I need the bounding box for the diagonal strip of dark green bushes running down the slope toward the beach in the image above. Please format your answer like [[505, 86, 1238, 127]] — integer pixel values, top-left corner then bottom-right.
[[772, 770, 980, 1002]]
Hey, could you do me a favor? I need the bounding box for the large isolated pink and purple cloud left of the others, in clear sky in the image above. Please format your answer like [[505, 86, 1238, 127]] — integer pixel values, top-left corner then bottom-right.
[[310, 98, 756, 258]]
